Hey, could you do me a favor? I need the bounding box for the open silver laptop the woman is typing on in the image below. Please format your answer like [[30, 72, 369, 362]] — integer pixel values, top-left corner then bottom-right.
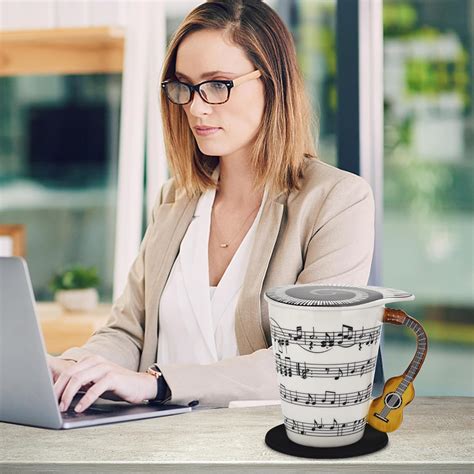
[[0, 257, 192, 429]]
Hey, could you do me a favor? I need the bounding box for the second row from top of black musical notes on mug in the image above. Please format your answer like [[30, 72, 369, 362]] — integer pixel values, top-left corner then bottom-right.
[[275, 354, 377, 380]]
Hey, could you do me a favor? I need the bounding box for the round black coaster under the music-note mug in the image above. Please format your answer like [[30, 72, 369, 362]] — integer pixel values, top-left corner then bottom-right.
[[265, 424, 388, 459]]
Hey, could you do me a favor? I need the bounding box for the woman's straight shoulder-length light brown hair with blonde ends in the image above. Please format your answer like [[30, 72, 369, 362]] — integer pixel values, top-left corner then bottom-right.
[[161, 0, 317, 197]]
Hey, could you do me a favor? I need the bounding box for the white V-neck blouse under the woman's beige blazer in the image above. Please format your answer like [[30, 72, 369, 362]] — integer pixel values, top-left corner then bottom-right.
[[157, 180, 267, 365]]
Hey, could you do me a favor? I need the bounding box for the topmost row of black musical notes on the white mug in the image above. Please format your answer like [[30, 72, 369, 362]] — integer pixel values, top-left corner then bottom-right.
[[270, 318, 382, 353]]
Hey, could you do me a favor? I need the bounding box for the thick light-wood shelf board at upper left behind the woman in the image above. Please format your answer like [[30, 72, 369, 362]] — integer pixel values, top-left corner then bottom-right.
[[0, 27, 125, 76]]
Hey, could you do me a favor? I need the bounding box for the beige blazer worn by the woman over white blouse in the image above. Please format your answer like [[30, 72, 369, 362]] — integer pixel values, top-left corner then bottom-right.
[[61, 159, 375, 407]]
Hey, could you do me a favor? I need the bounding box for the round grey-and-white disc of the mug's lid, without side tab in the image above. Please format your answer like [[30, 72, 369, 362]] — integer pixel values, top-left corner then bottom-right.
[[265, 284, 384, 307]]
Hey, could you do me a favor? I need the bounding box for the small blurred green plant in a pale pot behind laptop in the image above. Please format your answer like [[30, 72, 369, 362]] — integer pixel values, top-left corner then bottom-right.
[[49, 265, 100, 311]]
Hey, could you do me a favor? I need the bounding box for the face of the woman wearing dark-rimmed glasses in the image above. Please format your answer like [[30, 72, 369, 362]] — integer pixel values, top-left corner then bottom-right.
[[176, 30, 264, 160]]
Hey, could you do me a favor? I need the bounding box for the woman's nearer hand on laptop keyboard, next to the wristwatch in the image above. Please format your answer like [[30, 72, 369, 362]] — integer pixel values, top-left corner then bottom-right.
[[54, 355, 157, 412]]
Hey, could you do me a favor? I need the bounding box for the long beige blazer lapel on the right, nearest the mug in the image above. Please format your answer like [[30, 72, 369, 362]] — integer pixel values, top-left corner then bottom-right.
[[235, 193, 286, 355]]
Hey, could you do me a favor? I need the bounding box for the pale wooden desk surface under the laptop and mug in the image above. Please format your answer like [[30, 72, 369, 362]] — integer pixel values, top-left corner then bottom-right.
[[0, 397, 474, 474]]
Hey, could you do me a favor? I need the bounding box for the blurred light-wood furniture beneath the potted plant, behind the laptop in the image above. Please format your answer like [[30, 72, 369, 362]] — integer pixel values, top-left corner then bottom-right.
[[36, 302, 112, 355]]
